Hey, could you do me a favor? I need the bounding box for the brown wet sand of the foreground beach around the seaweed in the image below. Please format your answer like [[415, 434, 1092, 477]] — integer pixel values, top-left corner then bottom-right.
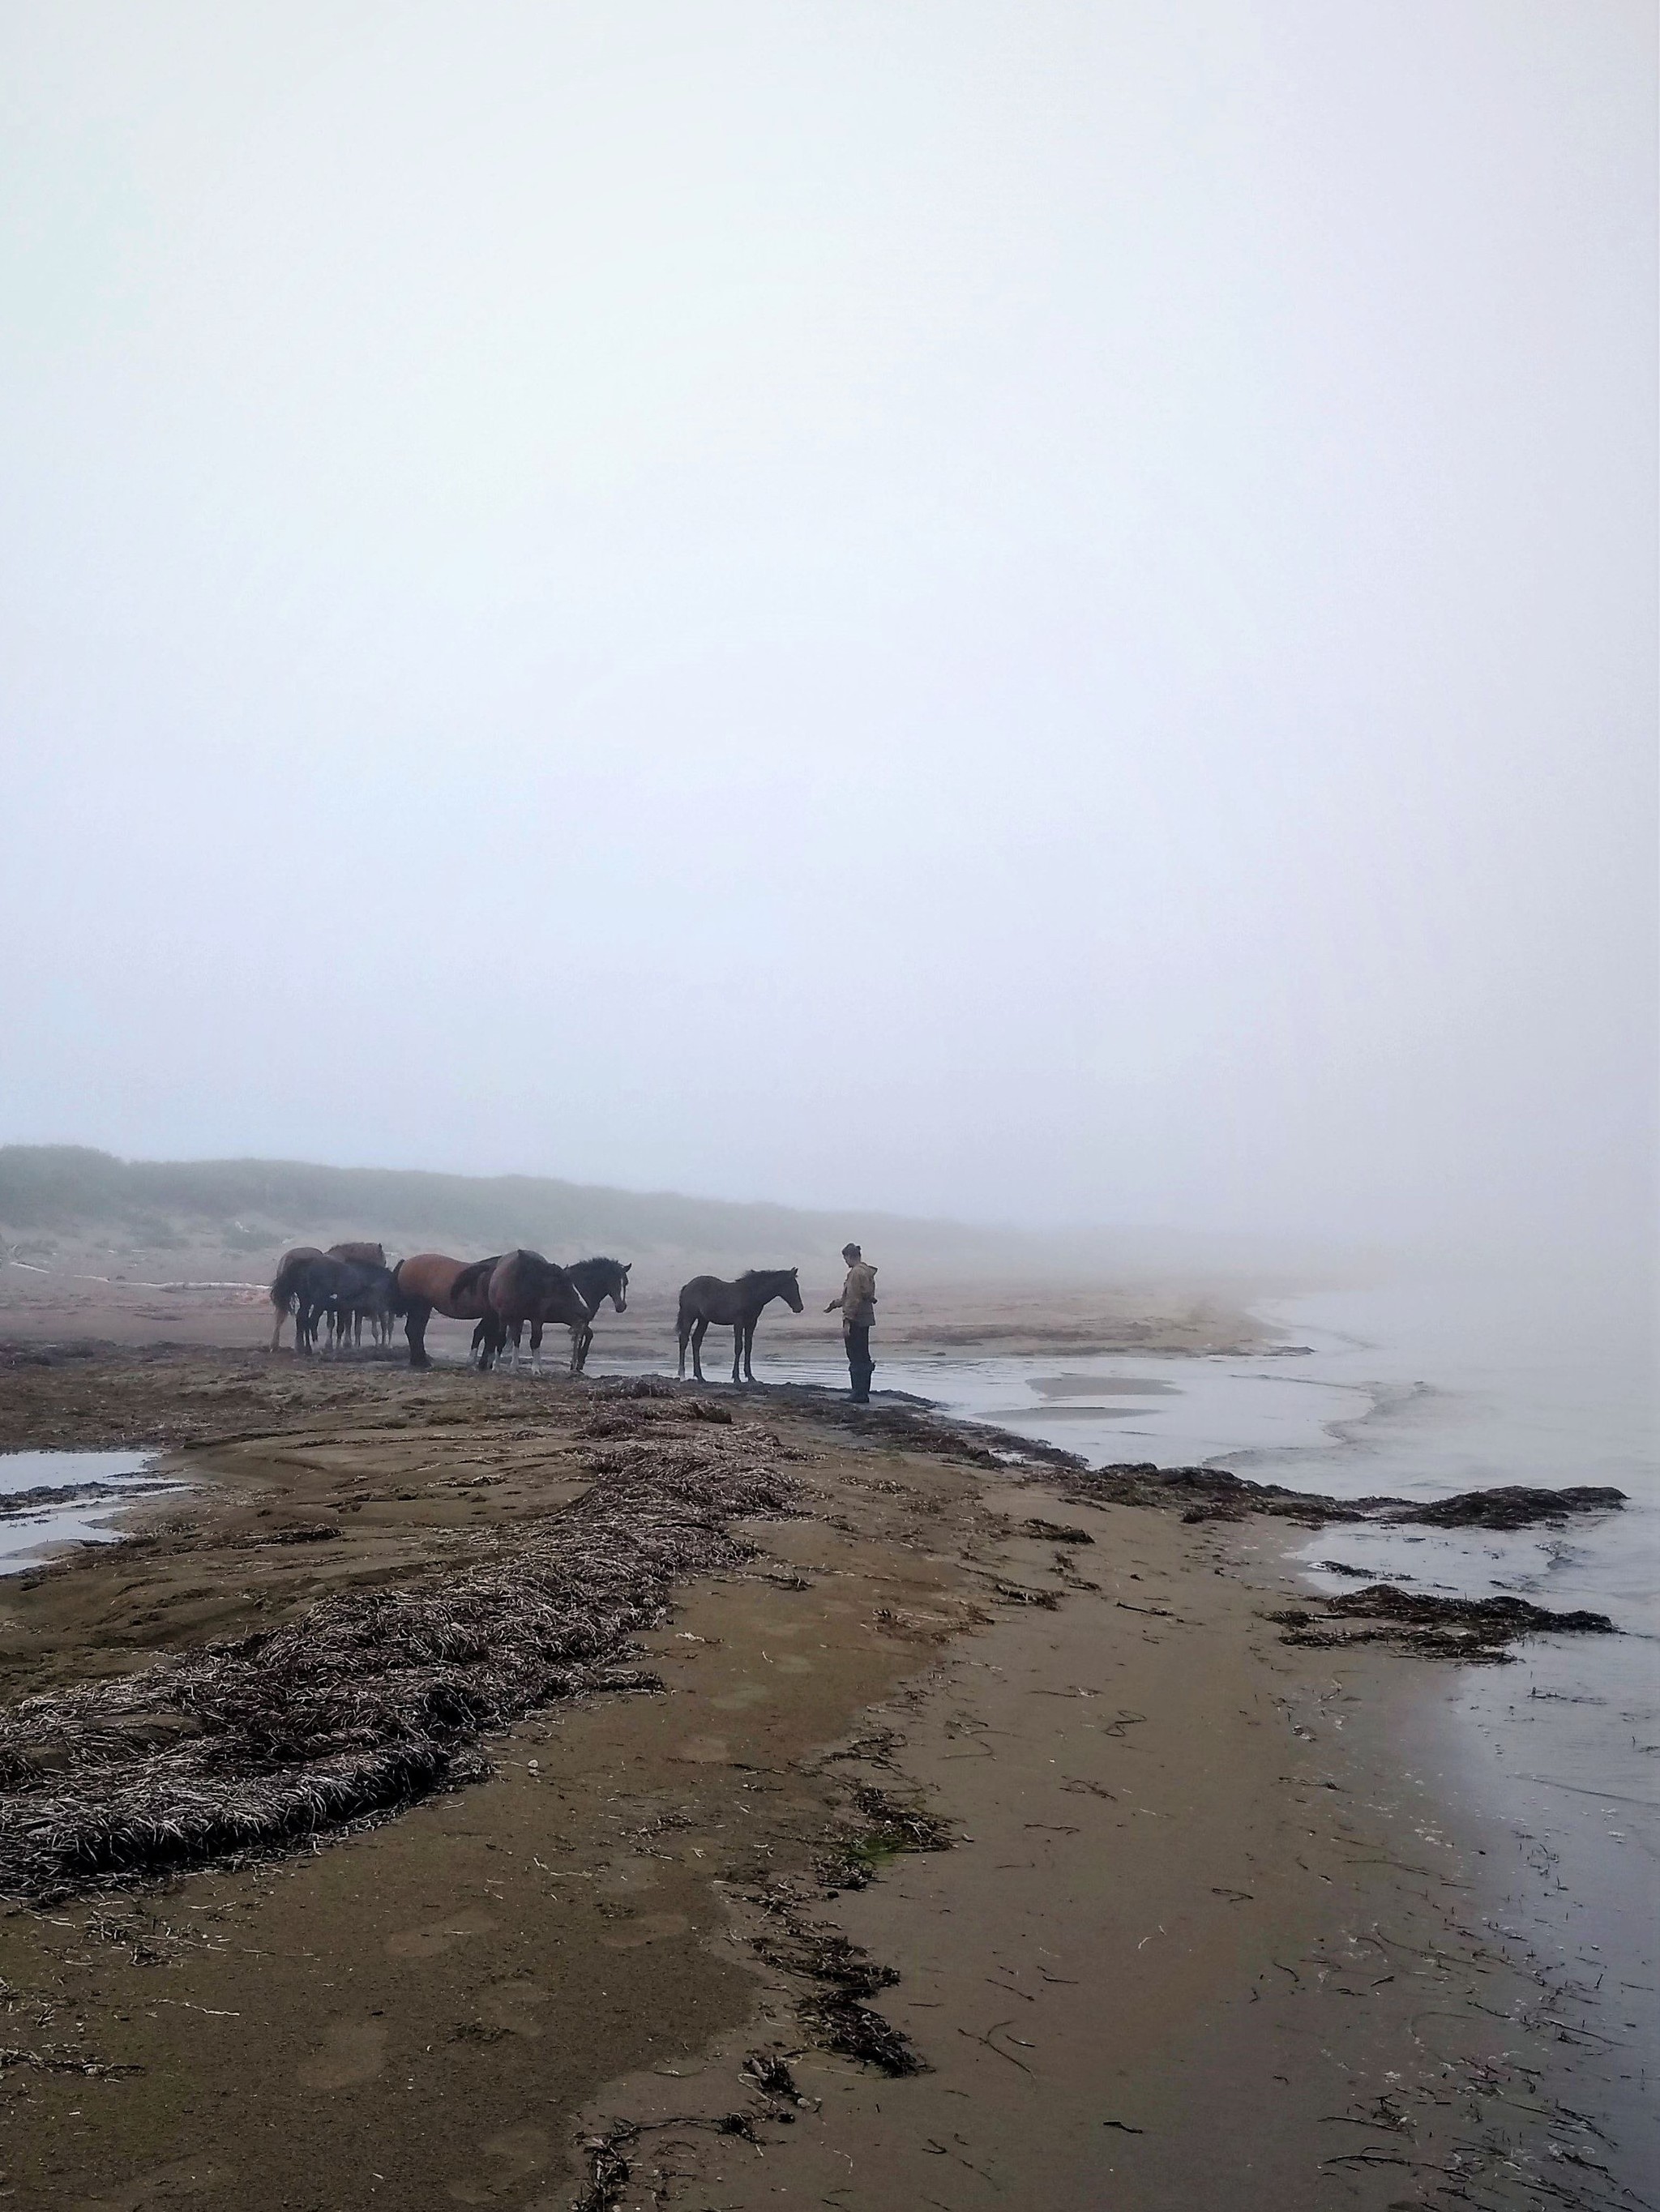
[[0, 1347, 1638, 2212]]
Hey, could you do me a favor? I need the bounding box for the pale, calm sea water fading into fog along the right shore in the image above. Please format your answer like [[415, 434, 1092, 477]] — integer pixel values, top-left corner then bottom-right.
[[752, 1272, 1660, 2170]]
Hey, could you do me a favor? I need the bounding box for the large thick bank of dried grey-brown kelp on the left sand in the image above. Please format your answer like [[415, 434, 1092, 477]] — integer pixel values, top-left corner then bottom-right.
[[0, 1429, 788, 1902]]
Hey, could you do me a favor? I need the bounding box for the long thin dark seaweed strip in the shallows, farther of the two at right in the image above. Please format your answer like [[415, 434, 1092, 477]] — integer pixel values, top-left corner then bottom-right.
[[1073, 1460, 1624, 1529]]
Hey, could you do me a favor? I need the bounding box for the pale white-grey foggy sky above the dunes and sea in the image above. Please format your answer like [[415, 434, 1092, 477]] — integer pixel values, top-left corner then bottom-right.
[[0, 0, 1656, 1239]]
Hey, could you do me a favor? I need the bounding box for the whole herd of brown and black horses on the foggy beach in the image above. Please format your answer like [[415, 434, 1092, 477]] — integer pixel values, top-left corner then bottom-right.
[[270, 1243, 802, 1383]]
